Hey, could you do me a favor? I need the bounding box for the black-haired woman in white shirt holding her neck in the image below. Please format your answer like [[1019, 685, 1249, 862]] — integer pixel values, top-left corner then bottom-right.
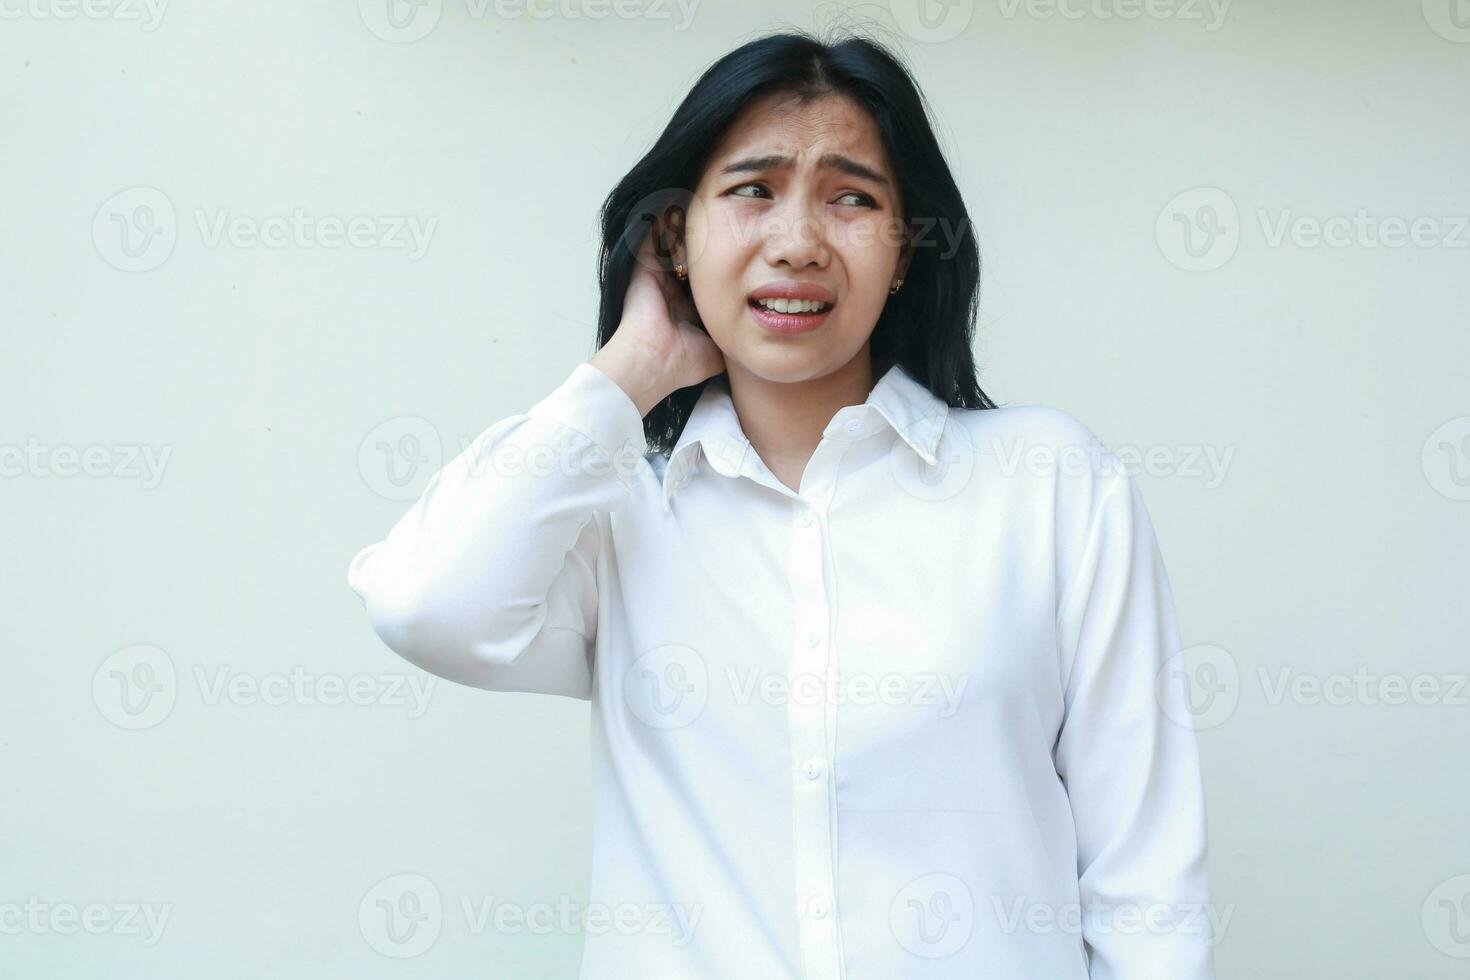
[[348, 34, 1213, 980]]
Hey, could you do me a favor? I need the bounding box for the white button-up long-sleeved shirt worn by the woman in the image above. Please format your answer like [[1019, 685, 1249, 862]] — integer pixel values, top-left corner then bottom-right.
[[348, 363, 1213, 980]]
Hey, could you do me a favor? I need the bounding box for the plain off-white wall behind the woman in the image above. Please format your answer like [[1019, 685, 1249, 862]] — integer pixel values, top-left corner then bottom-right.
[[0, 0, 1470, 980]]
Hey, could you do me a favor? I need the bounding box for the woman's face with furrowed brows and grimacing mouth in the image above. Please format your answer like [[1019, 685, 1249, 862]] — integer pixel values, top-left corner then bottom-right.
[[679, 96, 908, 382]]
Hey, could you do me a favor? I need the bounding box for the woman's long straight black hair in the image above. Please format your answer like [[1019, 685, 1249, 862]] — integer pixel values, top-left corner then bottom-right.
[[597, 31, 995, 454]]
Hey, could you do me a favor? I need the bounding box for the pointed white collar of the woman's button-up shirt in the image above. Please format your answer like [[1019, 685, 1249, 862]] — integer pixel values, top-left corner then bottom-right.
[[663, 364, 950, 507]]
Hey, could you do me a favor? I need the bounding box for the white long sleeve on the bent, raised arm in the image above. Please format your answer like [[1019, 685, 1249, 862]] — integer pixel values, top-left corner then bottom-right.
[[347, 361, 645, 699]]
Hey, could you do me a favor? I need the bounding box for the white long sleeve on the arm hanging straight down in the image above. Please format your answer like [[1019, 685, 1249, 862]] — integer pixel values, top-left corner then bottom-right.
[[1055, 469, 1214, 980]]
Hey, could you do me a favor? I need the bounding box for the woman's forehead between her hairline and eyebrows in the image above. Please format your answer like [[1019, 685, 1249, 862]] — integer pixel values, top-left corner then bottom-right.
[[710, 96, 889, 166]]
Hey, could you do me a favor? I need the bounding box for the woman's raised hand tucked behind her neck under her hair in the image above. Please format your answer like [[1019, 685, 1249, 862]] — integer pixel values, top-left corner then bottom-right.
[[591, 215, 725, 416]]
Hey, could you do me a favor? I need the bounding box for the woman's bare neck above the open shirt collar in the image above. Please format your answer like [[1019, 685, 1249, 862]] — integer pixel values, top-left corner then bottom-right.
[[728, 344, 875, 467]]
